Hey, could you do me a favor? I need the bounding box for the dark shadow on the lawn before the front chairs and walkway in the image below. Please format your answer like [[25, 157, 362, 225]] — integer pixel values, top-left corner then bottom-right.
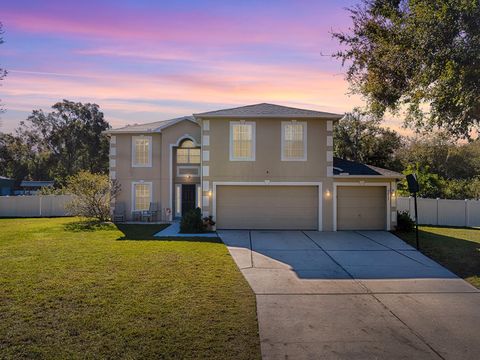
[[114, 224, 222, 243]]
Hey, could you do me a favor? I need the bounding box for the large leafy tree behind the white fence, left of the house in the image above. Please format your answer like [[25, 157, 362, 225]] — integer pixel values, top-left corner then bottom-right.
[[17, 100, 109, 185]]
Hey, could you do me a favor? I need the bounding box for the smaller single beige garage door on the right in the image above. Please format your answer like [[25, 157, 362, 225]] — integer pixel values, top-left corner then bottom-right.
[[337, 186, 387, 230]]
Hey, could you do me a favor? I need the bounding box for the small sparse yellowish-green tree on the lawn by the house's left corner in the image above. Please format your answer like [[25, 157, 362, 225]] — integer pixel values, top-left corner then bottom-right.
[[65, 170, 120, 222]]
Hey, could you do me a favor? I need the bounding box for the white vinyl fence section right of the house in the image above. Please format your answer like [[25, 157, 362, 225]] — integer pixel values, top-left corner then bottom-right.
[[397, 197, 480, 227]]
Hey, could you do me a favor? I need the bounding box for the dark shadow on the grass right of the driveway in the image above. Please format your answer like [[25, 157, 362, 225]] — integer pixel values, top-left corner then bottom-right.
[[395, 226, 480, 284]]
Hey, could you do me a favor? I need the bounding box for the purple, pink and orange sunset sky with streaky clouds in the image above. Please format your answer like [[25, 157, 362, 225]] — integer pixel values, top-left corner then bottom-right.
[[0, 0, 404, 131]]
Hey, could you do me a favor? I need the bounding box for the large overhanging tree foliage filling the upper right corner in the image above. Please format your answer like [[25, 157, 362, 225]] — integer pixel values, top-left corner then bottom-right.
[[333, 0, 480, 137]]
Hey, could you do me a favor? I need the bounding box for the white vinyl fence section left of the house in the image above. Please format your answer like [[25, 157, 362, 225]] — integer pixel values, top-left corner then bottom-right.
[[0, 195, 72, 217]]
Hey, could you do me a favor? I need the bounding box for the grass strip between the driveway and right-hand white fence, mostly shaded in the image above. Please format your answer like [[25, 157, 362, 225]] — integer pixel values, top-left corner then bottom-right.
[[396, 226, 480, 288]]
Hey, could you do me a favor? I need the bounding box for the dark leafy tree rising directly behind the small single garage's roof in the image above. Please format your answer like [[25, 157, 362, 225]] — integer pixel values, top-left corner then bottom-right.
[[333, 109, 403, 170]]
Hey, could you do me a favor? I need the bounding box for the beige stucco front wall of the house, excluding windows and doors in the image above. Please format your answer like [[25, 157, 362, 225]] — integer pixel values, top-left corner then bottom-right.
[[110, 118, 396, 231]]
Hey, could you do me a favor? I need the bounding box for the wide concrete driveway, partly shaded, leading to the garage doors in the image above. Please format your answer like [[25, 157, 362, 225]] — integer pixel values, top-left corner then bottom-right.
[[218, 230, 480, 359]]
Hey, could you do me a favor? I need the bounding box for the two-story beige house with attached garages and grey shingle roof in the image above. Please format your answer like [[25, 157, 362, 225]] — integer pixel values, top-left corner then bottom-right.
[[107, 103, 403, 231]]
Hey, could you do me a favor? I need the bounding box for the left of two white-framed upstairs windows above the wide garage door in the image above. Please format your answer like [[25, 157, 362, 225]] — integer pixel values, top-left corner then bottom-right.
[[230, 121, 255, 161]]
